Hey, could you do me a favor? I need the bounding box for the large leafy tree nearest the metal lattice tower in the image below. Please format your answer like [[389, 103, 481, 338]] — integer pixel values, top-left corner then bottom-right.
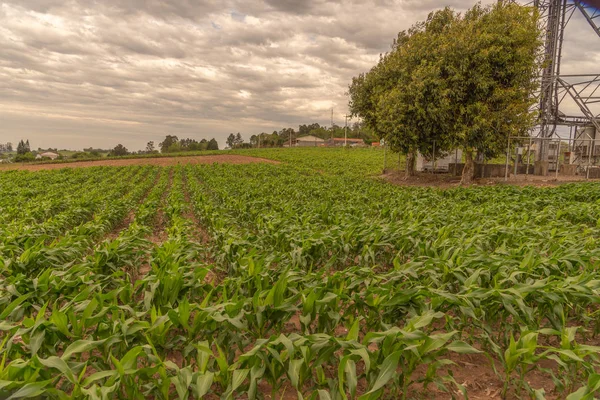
[[443, 2, 542, 183]]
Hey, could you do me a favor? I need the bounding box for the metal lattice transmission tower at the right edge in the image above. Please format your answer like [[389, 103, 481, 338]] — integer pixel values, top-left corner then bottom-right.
[[530, 0, 600, 170]]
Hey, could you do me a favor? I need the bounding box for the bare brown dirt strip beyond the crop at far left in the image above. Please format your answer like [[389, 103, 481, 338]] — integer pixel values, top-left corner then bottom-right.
[[0, 154, 279, 171]]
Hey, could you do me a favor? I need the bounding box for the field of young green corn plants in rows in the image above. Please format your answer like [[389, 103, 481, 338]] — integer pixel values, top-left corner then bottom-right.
[[0, 149, 600, 400]]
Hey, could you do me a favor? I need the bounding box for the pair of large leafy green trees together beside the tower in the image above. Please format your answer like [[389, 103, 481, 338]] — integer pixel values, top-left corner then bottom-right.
[[349, 1, 541, 183]]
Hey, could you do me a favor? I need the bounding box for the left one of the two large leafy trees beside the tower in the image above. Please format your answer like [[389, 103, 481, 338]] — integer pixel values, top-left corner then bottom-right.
[[349, 9, 455, 177]]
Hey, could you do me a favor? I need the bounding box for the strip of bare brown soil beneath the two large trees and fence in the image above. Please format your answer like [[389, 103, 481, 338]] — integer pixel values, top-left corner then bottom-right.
[[380, 171, 586, 189]]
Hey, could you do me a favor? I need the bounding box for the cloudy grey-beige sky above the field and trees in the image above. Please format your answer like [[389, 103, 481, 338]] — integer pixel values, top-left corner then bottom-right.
[[0, 0, 600, 150]]
